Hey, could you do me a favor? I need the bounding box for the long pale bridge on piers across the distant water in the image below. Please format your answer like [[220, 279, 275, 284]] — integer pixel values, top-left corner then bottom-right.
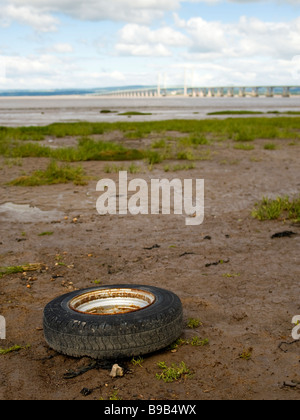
[[100, 86, 300, 98]]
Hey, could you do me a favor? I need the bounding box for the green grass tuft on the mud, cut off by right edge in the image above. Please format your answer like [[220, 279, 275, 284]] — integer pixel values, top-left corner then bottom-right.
[[252, 195, 300, 222]]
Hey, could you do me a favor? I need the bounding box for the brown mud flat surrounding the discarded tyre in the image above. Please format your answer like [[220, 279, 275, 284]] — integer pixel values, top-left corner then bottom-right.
[[0, 132, 300, 400]]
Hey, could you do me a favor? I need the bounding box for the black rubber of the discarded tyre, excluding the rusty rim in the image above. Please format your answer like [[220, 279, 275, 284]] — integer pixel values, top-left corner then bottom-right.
[[44, 285, 183, 360]]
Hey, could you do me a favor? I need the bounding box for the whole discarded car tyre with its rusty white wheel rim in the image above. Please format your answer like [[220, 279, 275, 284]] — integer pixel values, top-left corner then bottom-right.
[[44, 285, 183, 360]]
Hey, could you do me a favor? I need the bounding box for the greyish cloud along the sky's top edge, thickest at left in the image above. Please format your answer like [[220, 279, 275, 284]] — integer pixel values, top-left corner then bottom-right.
[[0, 0, 300, 32]]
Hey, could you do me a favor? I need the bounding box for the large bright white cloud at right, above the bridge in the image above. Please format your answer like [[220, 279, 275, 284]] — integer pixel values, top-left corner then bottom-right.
[[174, 14, 300, 59]]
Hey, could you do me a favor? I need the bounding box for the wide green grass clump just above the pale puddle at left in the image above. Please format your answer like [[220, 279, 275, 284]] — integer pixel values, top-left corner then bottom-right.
[[10, 161, 87, 187]]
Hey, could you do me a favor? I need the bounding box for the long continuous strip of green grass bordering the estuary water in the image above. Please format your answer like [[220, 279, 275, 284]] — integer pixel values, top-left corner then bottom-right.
[[0, 116, 300, 142]]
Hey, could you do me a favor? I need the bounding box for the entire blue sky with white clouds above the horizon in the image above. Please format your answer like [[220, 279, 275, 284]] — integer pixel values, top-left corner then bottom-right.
[[0, 0, 300, 89]]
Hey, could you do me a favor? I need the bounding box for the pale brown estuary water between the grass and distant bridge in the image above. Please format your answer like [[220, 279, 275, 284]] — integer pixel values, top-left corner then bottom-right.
[[0, 95, 300, 127]]
